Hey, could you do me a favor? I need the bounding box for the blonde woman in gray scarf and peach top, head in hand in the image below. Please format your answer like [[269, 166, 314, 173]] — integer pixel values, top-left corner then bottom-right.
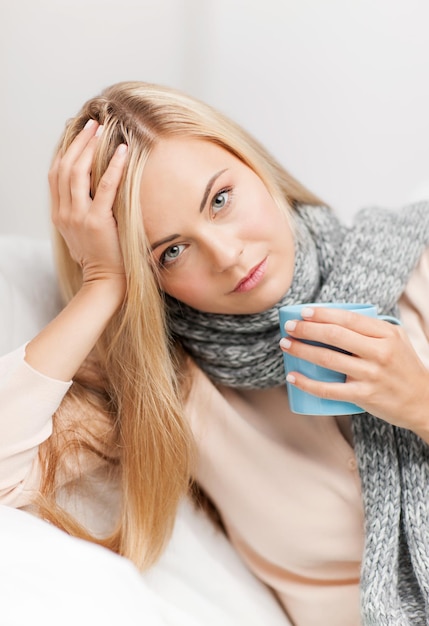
[[3, 83, 429, 626]]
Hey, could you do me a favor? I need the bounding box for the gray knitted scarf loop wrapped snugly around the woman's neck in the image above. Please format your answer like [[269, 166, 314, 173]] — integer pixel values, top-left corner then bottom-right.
[[167, 207, 345, 389]]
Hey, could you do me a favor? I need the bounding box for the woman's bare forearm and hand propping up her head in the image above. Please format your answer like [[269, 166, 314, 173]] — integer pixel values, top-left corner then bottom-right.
[[25, 122, 126, 381]]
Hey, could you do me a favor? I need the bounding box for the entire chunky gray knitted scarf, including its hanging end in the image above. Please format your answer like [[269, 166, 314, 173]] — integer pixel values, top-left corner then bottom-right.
[[167, 203, 429, 626]]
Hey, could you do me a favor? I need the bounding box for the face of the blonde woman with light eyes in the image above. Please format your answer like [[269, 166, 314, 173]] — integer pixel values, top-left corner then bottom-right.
[[141, 137, 294, 314]]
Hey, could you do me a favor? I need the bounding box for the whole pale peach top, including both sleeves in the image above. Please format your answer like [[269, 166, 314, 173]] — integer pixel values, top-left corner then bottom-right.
[[0, 250, 429, 626]]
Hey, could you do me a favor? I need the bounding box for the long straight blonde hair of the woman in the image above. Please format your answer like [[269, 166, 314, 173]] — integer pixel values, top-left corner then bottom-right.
[[41, 82, 320, 567]]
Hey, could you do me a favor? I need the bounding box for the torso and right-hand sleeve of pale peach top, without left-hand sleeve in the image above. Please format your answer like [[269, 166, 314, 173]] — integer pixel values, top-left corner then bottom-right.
[[184, 250, 429, 626]]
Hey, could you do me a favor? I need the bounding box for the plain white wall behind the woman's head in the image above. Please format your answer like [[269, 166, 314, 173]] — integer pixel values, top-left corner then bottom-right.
[[0, 0, 429, 237]]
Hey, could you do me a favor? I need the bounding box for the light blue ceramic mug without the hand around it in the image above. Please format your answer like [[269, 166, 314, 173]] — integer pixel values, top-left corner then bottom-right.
[[279, 302, 401, 415]]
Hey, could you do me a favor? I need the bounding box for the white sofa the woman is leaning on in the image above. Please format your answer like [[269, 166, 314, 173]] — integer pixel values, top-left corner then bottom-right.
[[0, 235, 289, 626]]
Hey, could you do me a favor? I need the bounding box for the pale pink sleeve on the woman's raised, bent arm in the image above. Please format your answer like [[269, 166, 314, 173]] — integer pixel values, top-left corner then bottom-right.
[[0, 346, 71, 507]]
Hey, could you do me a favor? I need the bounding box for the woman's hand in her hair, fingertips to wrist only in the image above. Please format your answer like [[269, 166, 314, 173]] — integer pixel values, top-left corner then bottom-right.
[[49, 120, 127, 285]]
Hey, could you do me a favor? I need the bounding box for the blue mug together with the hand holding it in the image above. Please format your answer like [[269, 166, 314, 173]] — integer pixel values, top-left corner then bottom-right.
[[280, 303, 429, 432]]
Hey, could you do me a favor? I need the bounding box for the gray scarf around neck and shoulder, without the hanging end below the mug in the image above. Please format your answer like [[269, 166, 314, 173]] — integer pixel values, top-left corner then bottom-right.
[[167, 203, 429, 389]]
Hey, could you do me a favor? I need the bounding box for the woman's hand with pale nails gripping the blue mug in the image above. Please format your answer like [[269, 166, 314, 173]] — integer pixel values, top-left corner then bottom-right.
[[280, 307, 429, 434]]
